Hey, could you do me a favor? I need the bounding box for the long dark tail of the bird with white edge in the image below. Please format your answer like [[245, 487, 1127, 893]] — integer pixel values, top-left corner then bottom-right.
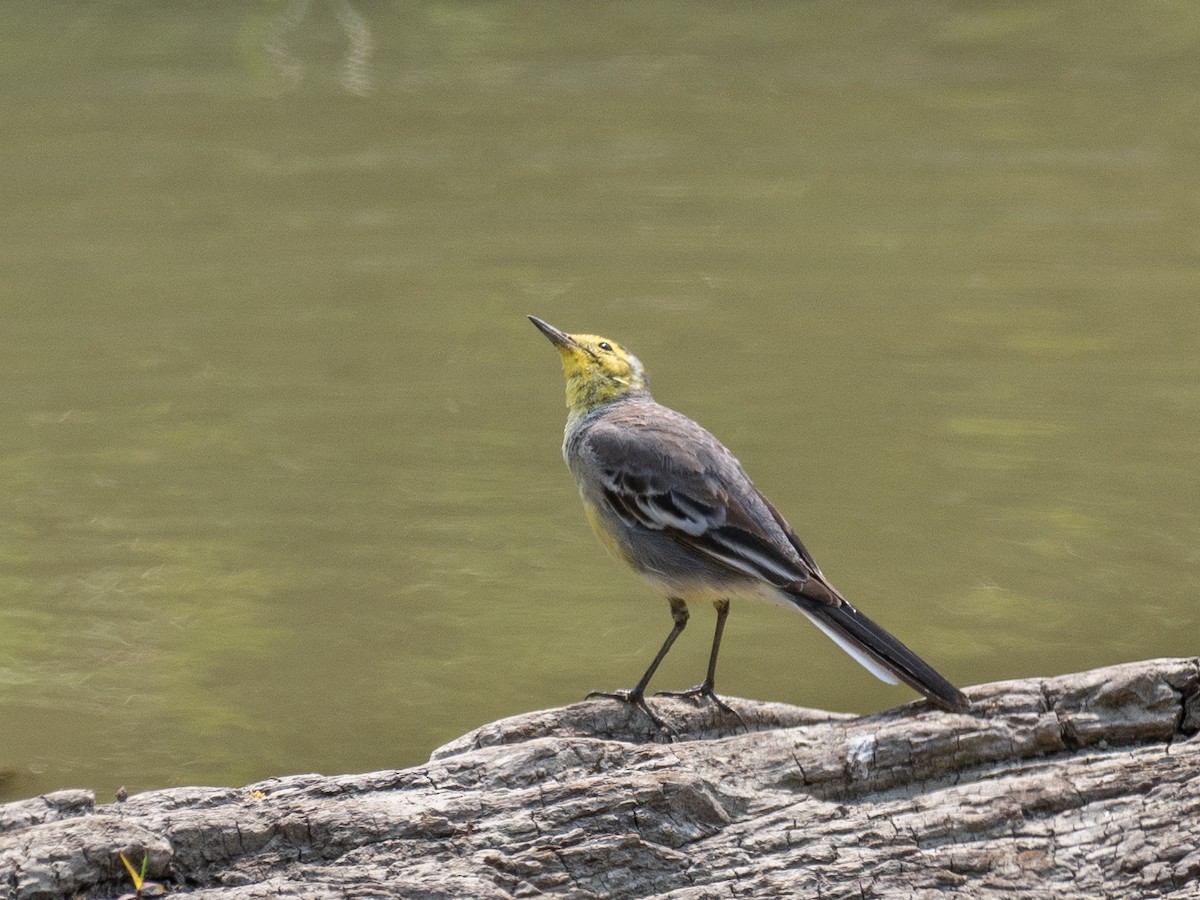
[[790, 594, 971, 713]]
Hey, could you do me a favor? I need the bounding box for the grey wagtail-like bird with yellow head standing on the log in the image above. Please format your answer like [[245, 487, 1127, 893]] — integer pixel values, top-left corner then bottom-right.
[[529, 316, 970, 731]]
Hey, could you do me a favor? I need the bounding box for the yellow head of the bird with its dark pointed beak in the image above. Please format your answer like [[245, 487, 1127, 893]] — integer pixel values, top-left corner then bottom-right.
[[529, 316, 647, 416]]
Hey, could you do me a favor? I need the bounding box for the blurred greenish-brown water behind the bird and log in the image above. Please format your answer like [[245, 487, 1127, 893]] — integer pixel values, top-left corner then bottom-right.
[[0, 0, 1200, 802]]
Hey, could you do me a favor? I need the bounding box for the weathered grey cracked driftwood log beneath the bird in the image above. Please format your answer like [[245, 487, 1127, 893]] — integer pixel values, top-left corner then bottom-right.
[[0, 659, 1200, 900]]
